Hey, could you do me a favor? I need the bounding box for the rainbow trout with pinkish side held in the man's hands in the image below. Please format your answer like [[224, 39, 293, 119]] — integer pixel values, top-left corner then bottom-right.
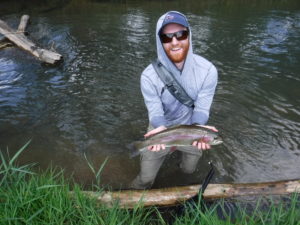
[[127, 125, 223, 158]]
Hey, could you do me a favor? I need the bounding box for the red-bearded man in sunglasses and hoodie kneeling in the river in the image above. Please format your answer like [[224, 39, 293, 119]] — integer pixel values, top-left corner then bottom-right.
[[132, 11, 218, 189]]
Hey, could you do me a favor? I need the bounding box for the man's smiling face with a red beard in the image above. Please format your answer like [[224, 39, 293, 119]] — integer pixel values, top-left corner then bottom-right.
[[162, 23, 190, 63]]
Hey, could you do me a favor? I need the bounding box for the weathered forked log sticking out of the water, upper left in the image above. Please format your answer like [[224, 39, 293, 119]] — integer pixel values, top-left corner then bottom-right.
[[0, 15, 63, 64]]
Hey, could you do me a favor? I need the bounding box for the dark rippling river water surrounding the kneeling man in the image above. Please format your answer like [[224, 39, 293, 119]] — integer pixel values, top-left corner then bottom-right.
[[0, 0, 300, 188]]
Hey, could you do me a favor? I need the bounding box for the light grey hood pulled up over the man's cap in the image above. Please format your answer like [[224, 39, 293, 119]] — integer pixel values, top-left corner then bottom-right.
[[155, 11, 193, 76]]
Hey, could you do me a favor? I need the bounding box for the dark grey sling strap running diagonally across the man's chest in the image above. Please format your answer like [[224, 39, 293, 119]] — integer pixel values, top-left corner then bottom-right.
[[152, 59, 194, 108]]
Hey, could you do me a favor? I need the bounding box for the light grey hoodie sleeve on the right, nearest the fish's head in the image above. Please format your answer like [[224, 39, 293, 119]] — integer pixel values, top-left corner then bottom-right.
[[192, 65, 218, 125]]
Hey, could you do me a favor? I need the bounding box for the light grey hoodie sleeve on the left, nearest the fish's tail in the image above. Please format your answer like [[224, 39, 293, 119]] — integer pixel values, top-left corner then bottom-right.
[[141, 75, 166, 128]]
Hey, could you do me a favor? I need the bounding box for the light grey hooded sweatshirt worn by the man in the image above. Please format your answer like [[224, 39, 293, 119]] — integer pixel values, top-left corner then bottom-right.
[[141, 13, 218, 128]]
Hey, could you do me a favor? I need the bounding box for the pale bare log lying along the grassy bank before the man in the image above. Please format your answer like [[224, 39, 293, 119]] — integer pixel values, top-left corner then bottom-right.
[[79, 180, 300, 208]]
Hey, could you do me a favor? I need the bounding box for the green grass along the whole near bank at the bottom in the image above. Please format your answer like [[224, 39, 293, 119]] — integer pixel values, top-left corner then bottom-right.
[[0, 142, 300, 225]]
